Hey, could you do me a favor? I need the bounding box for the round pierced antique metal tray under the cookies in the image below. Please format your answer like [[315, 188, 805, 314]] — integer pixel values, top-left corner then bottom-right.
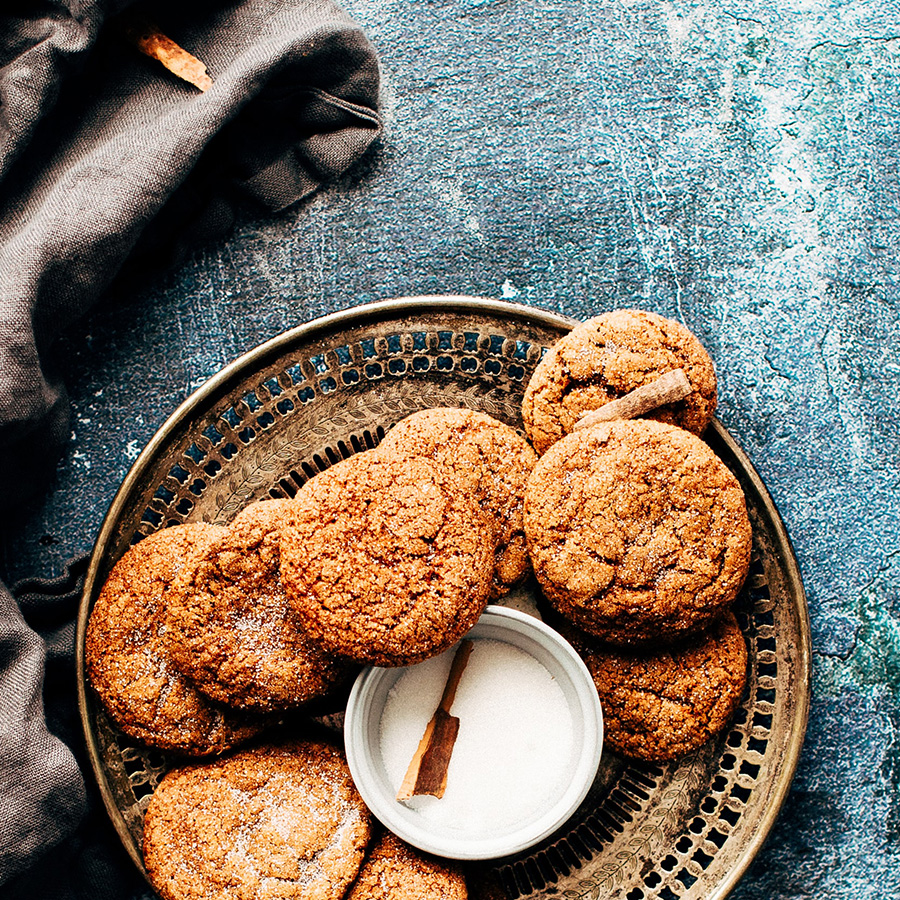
[[77, 297, 810, 900]]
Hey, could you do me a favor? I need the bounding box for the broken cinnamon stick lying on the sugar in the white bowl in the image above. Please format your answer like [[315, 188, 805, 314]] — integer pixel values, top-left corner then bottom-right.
[[397, 640, 473, 802]]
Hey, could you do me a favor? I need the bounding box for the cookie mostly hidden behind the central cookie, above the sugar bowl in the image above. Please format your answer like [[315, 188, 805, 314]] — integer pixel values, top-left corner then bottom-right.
[[379, 407, 537, 597]]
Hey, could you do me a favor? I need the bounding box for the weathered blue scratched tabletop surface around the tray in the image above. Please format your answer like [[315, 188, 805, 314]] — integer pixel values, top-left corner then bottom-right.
[[3, 0, 900, 900]]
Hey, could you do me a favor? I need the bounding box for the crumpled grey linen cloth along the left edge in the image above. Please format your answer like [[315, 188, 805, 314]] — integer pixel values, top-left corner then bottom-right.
[[0, 0, 380, 884]]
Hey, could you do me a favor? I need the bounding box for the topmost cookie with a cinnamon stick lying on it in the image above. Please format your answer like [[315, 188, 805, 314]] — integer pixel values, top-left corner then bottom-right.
[[522, 309, 716, 453]]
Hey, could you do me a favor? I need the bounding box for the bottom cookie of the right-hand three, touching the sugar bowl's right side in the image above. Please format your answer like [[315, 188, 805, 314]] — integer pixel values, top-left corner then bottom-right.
[[563, 612, 747, 762]]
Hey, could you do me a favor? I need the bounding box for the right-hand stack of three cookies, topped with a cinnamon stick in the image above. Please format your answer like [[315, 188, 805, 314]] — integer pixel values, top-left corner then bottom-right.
[[522, 310, 752, 761]]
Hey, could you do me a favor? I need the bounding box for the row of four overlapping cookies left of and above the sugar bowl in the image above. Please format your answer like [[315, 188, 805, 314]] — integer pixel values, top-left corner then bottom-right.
[[85, 409, 537, 756]]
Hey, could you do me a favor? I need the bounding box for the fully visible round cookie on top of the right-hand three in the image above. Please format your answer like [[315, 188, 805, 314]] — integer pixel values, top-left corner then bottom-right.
[[525, 419, 752, 645]]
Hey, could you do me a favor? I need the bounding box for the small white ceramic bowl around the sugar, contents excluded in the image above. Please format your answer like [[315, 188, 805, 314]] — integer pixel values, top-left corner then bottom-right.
[[344, 606, 603, 859]]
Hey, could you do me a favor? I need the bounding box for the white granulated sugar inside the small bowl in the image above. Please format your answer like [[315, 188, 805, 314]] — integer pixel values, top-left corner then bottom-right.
[[380, 640, 573, 836]]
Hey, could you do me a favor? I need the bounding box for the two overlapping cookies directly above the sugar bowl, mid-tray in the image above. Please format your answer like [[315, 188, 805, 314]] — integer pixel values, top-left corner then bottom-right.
[[281, 409, 537, 666]]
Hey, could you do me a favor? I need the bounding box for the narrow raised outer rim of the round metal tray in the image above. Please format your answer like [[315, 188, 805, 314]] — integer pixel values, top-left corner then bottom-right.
[[75, 295, 812, 900]]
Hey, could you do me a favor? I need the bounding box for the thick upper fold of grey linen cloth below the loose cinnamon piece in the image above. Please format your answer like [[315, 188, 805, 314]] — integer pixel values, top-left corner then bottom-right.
[[0, 0, 381, 503]]
